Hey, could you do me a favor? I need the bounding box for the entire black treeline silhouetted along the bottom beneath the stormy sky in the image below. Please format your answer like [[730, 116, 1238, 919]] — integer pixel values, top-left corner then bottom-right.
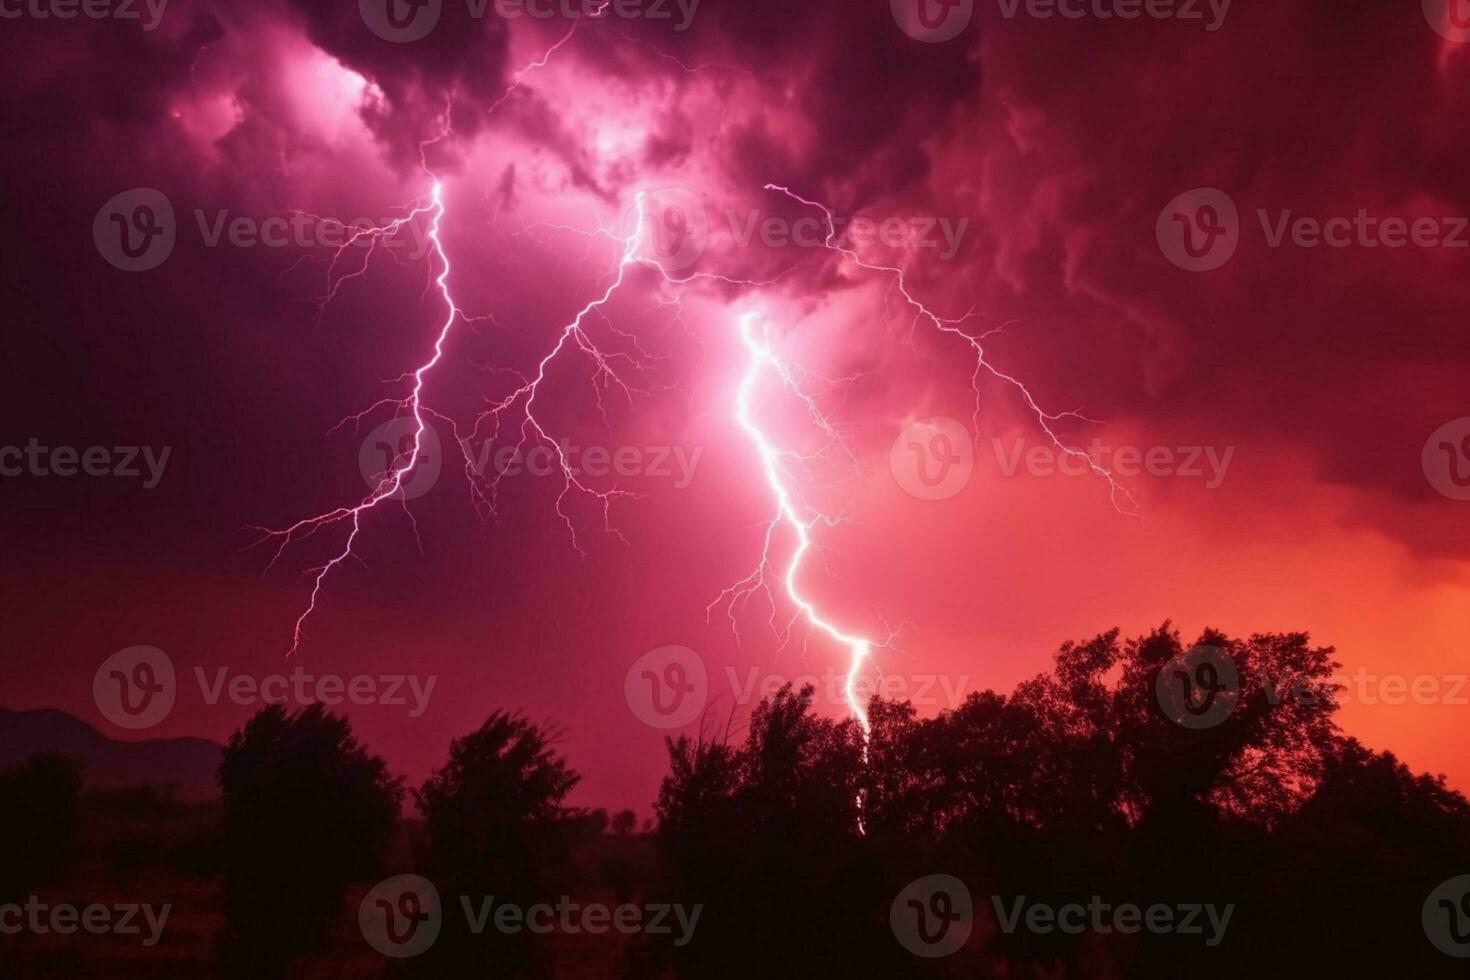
[[0, 623, 1470, 979]]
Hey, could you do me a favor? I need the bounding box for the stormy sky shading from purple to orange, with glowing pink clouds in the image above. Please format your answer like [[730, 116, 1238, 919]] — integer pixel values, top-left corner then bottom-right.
[[0, 0, 1470, 813]]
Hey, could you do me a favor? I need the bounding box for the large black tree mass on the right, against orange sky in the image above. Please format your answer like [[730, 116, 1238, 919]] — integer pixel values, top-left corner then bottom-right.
[[655, 623, 1470, 980]]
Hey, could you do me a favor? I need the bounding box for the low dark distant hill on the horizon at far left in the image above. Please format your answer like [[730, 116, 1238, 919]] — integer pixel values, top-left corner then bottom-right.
[[0, 708, 223, 801]]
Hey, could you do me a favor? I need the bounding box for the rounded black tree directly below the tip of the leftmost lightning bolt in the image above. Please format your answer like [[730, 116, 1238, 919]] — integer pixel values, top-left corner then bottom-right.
[[219, 704, 403, 977]]
